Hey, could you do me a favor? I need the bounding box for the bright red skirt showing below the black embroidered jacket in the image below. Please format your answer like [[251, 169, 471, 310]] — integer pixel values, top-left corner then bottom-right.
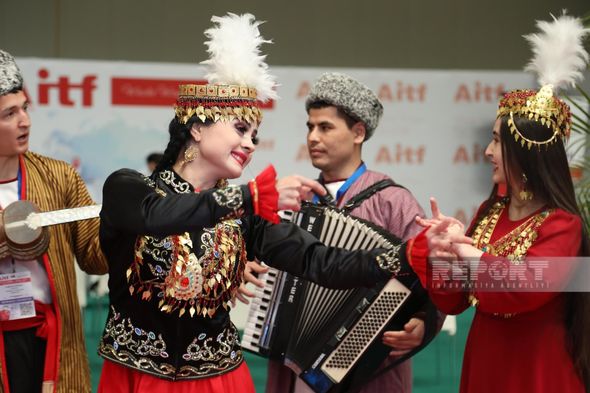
[[98, 360, 256, 393]]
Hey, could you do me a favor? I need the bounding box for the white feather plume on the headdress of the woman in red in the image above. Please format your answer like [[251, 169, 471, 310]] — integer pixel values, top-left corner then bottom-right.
[[524, 11, 590, 88]]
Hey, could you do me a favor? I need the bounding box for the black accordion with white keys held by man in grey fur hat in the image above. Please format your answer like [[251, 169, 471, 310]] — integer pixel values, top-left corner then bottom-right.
[[242, 203, 428, 393]]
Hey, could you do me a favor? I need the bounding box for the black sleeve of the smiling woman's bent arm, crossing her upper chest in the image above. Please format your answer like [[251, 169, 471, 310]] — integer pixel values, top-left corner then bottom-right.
[[100, 169, 252, 236]]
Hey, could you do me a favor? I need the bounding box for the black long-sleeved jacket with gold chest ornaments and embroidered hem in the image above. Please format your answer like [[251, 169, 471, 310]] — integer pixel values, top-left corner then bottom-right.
[[99, 169, 408, 380]]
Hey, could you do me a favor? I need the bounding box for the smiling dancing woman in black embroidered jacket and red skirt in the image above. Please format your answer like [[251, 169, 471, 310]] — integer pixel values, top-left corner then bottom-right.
[[99, 15, 409, 393]]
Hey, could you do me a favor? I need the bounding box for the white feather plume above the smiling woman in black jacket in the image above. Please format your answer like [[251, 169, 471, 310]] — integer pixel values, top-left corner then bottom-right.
[[201, 13, 278, 101]]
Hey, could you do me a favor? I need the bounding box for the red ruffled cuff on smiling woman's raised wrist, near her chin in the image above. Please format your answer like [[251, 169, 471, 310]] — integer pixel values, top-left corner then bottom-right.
[[248, 165, 281, 224]]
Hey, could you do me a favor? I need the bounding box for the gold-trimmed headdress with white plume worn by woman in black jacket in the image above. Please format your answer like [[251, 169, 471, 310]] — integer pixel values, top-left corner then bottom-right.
[[175, 13, 277, 123]]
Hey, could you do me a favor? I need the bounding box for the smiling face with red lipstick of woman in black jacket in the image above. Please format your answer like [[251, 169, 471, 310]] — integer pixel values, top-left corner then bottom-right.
[[191, 120, 258, 179]]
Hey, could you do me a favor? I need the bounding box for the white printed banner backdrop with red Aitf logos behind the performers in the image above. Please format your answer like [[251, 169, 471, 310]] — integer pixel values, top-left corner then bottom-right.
[[18, 58, 534, 220]]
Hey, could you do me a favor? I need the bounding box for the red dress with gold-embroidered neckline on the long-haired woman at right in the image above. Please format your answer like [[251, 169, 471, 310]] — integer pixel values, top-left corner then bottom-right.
[[409, 205, 585, 393]]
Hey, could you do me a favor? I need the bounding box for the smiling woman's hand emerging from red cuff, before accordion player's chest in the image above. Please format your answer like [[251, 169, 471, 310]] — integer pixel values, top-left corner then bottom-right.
[[276, 175, 326, 211]]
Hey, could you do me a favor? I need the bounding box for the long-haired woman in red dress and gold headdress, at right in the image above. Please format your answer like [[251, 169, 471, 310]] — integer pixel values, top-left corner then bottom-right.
[[408, 16, 590, 393]]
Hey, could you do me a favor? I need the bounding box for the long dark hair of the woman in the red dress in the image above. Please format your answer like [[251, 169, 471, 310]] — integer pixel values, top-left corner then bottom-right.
[[467, 116, 590, 389]]
